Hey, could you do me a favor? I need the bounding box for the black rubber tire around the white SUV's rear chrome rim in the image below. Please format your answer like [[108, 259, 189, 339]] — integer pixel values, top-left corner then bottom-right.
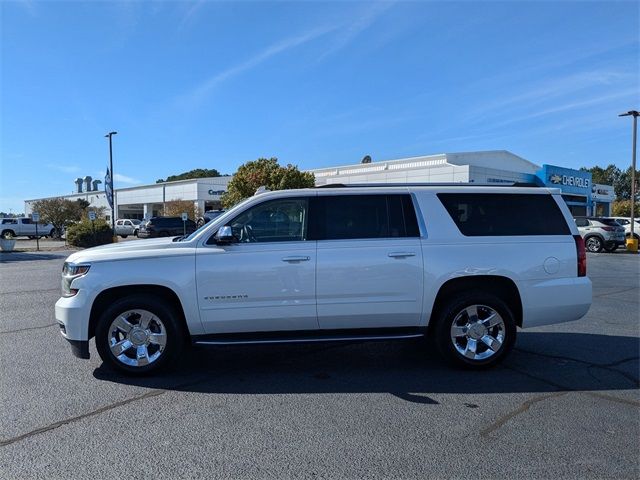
[[434, 291, 516, 369]]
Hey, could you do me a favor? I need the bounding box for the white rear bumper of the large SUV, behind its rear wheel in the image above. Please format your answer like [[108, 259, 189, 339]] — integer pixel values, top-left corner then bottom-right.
[[520, 277, 592, 328]]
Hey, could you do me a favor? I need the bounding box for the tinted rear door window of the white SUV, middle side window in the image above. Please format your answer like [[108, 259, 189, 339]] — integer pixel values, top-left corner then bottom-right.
[[311, 194, 420, 240]]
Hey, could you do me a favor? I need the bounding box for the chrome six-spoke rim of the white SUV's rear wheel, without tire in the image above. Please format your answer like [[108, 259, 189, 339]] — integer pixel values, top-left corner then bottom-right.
[[451, 305, 506, 360]]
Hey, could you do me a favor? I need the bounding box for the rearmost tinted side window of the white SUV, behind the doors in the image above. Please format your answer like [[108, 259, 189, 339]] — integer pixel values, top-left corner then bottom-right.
[[438, 193, 571, 237]]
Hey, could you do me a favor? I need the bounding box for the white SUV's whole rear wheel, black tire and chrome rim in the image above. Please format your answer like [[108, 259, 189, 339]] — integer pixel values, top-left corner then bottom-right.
[[435, 292, 516, 369]]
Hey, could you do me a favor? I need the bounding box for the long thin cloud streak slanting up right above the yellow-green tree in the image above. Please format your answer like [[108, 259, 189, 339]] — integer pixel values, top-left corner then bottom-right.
[[183, 26, 336, 104]]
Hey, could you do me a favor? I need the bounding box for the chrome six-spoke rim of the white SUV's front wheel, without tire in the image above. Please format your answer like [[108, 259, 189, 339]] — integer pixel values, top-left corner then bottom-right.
[[107, 310, 167, 367]]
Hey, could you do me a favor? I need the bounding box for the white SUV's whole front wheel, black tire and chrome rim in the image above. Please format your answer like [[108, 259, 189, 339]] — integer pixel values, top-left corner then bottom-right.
[[96, 294, 185, 375]]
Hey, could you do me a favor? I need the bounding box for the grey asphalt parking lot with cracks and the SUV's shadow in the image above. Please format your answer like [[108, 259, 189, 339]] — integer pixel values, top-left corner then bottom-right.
[[0, 251, 640, 479]]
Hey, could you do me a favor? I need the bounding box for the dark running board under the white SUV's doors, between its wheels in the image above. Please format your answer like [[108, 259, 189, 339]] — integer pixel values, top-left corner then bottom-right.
[[193, 328, 424, 345]]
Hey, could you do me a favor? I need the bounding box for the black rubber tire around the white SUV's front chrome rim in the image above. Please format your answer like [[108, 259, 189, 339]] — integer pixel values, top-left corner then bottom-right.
[[95, 294, 186, 375]]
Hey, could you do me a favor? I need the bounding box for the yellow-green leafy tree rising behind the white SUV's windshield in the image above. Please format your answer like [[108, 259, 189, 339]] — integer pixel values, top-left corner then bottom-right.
[[222, 158, 315, 208]]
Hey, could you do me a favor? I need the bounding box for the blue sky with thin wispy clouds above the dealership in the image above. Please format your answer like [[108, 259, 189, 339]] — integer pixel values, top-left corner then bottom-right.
[[0, 0, 640, 212]]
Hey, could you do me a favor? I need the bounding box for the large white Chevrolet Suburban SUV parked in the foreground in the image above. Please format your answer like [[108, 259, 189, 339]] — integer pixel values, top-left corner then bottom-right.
[[55, 185, 591, 374]]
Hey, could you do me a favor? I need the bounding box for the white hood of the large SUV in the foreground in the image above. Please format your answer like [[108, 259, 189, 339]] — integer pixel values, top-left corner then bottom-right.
[[67, 238, 195, 263]]
